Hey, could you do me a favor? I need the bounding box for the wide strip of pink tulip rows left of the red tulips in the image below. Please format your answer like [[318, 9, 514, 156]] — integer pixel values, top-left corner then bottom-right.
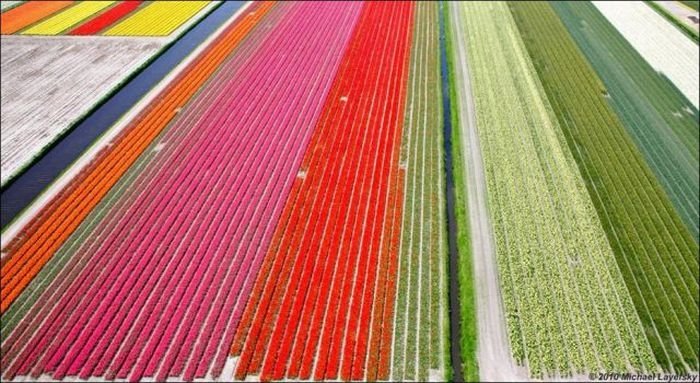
[[2, 0, 364, 380]]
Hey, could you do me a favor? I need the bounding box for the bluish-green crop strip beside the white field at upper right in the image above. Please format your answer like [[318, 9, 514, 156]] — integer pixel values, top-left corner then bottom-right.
[[552, 1, 700, 243]]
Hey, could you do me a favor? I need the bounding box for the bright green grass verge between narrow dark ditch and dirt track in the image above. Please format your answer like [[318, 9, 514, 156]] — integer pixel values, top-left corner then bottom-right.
[[443, 6, 479, 382]]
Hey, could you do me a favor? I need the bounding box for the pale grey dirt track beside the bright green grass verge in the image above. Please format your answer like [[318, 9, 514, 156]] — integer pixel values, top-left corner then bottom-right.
[[450, 3, 528, 381]]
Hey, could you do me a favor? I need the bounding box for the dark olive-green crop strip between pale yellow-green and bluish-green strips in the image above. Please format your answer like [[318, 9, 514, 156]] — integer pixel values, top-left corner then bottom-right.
[[509, 2, 698, 371]]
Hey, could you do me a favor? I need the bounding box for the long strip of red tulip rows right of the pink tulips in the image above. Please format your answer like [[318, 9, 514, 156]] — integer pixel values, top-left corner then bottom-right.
[[232, 2, 414, 380]]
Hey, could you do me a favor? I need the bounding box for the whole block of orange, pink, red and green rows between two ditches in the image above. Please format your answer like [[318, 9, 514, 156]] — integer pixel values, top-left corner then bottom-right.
[[0, 3, 454, 380]]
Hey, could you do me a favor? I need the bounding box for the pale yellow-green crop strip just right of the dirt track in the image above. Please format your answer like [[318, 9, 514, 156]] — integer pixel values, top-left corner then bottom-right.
[[457, 2, 656, 377]]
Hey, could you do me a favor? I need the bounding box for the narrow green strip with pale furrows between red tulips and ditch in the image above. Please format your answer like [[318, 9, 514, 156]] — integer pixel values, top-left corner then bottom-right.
[[392, 3, 449, 381]]
